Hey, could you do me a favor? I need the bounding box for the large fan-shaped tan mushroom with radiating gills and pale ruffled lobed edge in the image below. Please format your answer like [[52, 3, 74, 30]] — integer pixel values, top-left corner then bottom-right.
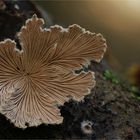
[[0, 15, 107, 128]]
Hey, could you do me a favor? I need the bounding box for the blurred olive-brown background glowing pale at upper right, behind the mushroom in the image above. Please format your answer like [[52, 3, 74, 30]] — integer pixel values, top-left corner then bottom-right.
[[33, 0, 140, 86]]
